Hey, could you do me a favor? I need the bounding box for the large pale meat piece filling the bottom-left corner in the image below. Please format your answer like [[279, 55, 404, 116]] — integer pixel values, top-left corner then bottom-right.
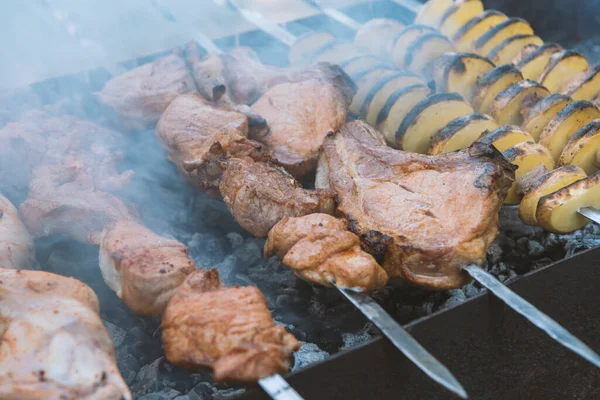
[[0, 269, 132, 400]]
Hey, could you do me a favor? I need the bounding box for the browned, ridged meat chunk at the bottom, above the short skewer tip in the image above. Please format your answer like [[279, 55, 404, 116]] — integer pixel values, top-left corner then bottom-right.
[[162, 269, 300, 382]]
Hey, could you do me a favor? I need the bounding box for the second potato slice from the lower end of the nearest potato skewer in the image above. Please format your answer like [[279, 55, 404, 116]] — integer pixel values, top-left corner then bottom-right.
[[519, 166, 587, 225]]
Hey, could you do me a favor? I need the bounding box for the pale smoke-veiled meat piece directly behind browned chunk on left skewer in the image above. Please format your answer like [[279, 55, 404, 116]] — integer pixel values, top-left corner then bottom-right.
[[19, 165, 137, 244]]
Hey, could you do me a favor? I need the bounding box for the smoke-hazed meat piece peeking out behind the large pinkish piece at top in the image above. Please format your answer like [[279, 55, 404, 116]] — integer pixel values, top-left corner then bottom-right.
[[187, 44, 355, 105]]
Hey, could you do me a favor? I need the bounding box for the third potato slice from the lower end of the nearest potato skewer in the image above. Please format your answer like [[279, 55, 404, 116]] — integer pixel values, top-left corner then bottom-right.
[[502, 142, 554, 204]]
